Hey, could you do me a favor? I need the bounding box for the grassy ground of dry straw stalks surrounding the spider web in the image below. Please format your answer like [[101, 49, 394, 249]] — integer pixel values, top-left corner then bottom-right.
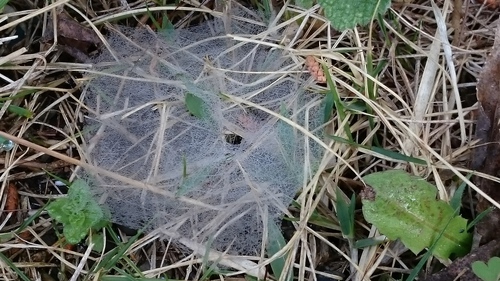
[[0, 0, 500, 281]]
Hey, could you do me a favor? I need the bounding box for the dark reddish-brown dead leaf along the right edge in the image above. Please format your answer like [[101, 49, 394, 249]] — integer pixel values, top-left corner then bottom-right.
[[471, 20, 500, 243]]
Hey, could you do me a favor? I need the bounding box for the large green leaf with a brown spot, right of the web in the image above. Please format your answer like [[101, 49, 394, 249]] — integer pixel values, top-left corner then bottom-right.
[[362, 170, 472, 259]]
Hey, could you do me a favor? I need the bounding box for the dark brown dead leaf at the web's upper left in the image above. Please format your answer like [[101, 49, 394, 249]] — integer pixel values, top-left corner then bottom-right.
[[43, 12, 101, 62]]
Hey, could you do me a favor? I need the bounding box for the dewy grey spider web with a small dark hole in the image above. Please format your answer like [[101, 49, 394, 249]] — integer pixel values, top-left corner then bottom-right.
[[82, 8, 323, 255]]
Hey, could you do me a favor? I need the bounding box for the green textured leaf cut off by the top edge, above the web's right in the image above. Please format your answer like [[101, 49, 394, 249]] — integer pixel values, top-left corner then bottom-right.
[[318, 0, 391, 31]]
